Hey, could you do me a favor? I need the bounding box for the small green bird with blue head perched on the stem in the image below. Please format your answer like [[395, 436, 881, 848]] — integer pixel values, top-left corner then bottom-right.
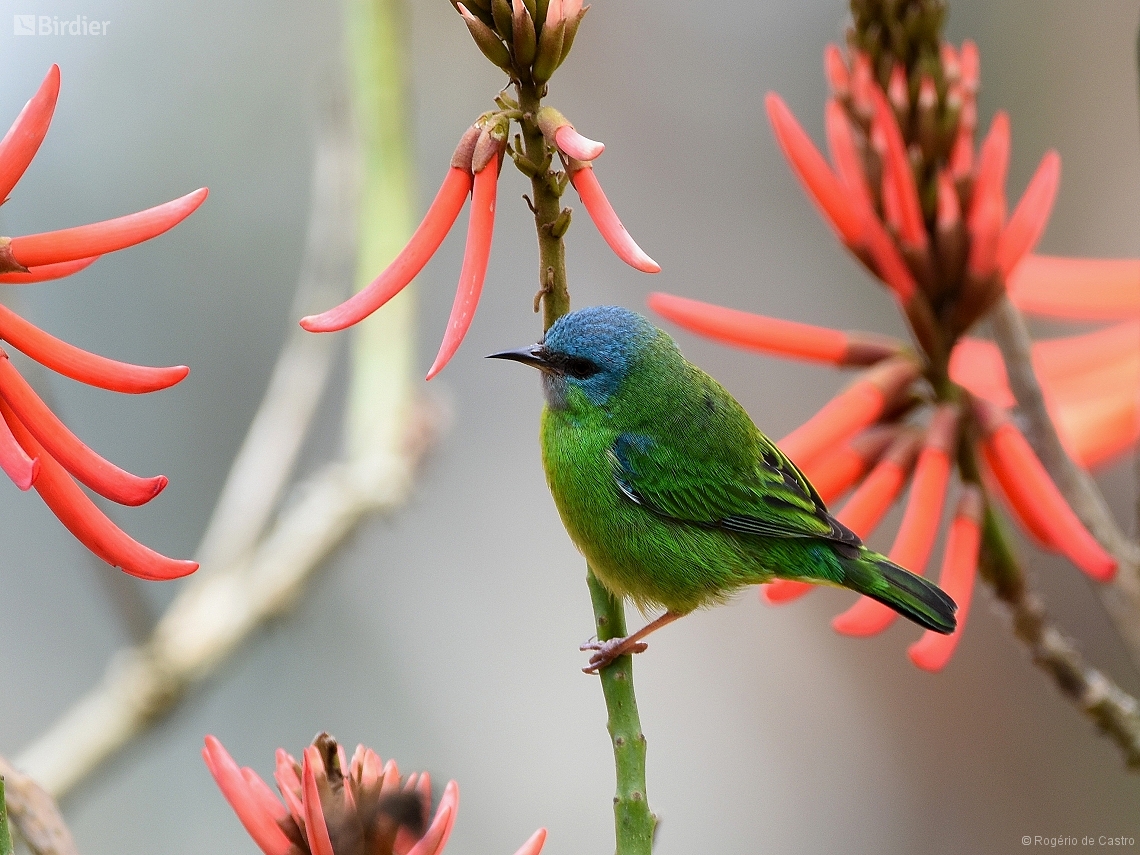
[[488, 306, 956, 674]]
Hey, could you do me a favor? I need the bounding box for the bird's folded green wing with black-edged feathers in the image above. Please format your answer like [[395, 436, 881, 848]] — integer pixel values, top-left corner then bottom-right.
[[610, 423, 862, 547]]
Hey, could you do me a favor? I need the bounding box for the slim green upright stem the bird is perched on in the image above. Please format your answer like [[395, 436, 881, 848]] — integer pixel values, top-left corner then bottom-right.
[[519, 83, 657, 855]]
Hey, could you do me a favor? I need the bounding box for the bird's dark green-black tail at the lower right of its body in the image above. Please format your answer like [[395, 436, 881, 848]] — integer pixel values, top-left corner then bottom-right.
[[840, 547, 958, 635]]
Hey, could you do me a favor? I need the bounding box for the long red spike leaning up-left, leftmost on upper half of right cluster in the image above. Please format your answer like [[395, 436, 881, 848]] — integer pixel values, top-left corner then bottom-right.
[[764, 92, 863, 247]]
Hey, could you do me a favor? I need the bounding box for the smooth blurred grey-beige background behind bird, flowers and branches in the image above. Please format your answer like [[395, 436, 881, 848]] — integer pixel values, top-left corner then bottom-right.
[[0, 0, 1140, 855]]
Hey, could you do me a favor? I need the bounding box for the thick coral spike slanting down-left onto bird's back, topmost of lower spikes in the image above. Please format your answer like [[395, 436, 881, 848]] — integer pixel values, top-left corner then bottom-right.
[[777, 358, 920, 466]]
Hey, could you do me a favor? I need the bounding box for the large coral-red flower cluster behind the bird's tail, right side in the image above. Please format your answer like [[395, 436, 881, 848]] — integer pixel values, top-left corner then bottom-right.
[[650, 0, 1140, 670]]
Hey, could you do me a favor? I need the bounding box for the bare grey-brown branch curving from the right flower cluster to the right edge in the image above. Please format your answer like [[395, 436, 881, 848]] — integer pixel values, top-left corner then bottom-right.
[[991, 298, 1140, 670]]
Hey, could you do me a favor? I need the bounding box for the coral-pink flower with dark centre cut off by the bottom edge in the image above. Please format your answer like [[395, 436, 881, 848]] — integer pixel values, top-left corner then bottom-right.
[[202, 733, 546, 855]]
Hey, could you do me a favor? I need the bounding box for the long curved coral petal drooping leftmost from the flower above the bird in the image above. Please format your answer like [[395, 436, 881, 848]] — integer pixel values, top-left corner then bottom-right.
[[301, 166, 472, 333]]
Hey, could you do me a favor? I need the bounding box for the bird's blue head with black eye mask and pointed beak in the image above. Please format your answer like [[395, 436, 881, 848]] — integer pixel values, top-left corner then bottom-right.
[[491, 306, 658, 409]]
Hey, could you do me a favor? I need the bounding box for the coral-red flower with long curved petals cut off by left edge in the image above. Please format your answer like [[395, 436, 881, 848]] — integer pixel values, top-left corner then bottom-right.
[[0, 66, 201, 579]]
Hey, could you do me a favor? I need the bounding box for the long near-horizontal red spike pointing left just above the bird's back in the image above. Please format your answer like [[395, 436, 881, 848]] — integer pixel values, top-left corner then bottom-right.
[[648, 292, 903, 366]]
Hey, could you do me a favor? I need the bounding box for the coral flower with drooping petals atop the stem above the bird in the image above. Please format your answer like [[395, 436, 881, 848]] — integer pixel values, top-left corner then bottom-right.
[[301, 0, 661, 380]]
